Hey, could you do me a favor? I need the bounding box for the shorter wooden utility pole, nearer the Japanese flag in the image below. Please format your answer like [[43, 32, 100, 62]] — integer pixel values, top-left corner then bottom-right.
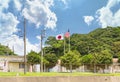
[[40, 30, 45, 72]]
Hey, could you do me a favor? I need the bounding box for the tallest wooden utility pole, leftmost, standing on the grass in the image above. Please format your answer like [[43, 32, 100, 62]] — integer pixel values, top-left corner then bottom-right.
[[24, 18, 26, 74]]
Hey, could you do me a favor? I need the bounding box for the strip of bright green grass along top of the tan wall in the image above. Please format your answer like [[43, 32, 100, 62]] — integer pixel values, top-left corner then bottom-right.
[[0, 72, 120, 77]]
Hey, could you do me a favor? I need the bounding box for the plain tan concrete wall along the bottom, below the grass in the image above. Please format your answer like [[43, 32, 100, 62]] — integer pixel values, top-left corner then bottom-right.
[[0, 76, 120, 82]]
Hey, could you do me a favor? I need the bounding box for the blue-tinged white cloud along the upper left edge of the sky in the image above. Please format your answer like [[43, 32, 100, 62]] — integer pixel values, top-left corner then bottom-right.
[[0, 0, 19, 37]]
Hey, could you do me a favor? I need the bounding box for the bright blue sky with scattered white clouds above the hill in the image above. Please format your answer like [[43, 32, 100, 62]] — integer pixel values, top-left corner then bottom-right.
[[0, 0, 120, 56]]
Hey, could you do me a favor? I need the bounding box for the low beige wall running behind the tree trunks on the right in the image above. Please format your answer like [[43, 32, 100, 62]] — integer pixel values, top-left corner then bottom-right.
[[58, 63, 120, 73]]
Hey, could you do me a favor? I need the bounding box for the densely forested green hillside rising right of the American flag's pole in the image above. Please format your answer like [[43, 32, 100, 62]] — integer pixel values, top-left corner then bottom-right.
[[71, 27, 120, 55]]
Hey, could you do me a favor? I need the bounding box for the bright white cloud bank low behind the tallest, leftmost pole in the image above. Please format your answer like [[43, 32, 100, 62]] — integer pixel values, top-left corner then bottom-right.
[[1, 35, 40, 56]]
